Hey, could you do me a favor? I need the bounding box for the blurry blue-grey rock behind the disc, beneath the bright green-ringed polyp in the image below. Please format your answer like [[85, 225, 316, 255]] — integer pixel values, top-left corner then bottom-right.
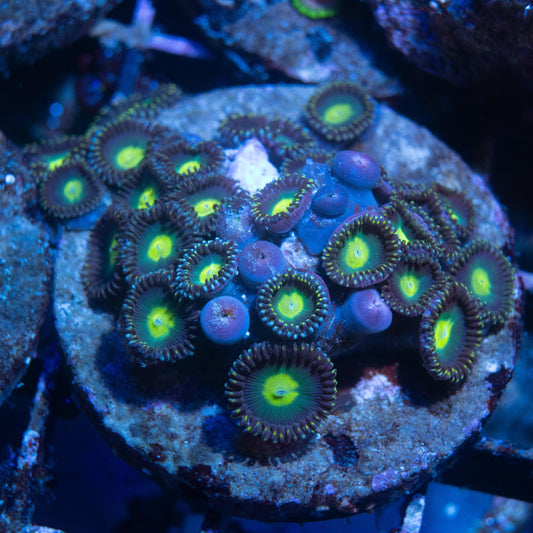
[[177, 0, 403, 99]]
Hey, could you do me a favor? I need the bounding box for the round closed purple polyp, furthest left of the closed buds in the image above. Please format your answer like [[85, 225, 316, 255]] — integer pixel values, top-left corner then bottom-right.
[[200, 296, 250, 346]]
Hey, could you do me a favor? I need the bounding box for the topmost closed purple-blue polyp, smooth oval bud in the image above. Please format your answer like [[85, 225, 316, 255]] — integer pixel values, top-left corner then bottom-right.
[[331, 150, 381, 189]]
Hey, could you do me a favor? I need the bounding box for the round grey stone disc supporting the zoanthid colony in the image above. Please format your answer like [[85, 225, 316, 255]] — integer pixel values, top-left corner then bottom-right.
[[55, 86, 522, 521]]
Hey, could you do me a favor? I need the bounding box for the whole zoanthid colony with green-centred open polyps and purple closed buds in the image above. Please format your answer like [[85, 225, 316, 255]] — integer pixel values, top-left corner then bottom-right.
[[26, 82, 513, 446]]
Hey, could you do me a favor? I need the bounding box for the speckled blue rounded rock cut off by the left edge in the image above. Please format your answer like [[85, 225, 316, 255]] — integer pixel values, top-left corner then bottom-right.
[[0, 132, 52, 403]]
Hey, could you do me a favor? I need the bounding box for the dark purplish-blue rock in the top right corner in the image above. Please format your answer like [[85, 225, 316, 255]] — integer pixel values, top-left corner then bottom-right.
[[371, 0, 533, 85]]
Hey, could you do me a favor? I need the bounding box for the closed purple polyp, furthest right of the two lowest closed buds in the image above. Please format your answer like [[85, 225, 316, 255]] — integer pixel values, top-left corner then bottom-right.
[[339, 289, 392, 334]]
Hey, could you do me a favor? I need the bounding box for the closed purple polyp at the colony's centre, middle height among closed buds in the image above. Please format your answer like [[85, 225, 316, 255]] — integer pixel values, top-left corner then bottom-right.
[[237, 241, 289, 289]]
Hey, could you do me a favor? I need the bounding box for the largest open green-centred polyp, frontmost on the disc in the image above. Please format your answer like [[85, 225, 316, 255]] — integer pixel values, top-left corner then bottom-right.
[[226, 342, 336, 443]]
